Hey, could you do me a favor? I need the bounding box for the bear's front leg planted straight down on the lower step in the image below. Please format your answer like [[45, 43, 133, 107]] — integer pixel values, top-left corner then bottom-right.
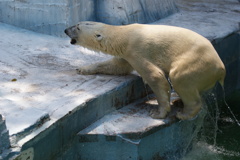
[[128, 57, 171, 119]]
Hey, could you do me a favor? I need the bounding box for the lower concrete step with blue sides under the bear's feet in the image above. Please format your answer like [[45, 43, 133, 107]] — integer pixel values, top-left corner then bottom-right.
[[58, 96, 206, 160]]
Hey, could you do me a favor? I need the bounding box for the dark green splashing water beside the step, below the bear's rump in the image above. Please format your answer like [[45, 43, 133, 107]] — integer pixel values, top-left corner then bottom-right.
[[181, 100, 240, 160]]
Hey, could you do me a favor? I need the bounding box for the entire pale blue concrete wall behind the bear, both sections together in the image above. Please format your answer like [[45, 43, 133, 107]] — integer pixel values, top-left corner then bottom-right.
[[0, 0, 177, 36]]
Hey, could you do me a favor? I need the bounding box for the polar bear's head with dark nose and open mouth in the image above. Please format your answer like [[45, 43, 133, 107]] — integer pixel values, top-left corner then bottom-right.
[[64, 21, 104, 48]]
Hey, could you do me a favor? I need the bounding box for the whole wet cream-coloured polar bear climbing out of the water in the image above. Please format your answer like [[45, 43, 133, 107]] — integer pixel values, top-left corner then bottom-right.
[[65, 21, 226, 120]]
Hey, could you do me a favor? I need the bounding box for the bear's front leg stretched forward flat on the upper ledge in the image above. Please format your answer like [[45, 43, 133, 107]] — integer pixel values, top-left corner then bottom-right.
[[77, 57, 133, 75]]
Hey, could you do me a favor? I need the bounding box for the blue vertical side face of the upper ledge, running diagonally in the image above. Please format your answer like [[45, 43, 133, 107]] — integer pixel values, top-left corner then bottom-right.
[[16, 78, 150, 160]]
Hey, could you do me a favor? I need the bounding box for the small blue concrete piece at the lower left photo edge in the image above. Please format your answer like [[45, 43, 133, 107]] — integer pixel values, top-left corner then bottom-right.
[[0, 114, 10, 154]]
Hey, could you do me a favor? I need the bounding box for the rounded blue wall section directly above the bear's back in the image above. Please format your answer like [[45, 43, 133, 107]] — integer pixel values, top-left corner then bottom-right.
[[96, 0, 177, 25]]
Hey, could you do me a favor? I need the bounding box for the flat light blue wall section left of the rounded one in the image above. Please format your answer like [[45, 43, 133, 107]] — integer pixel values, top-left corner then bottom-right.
[[0, 0, 94, 36]]
